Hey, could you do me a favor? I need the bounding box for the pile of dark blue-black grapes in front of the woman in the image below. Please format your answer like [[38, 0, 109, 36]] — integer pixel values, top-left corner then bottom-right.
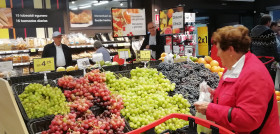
[[158, 61, 219, 110]]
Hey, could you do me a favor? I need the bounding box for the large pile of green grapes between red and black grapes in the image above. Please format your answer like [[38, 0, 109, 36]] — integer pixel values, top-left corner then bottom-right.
[[106, 68, 190, 133]]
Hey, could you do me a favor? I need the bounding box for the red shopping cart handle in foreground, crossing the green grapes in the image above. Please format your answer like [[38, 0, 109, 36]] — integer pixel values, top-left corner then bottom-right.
[[126, 113, 234, 134]]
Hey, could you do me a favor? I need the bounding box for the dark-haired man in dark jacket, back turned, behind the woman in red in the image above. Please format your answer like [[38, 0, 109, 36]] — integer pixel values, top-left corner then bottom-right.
[[251, 14, 280, 81]]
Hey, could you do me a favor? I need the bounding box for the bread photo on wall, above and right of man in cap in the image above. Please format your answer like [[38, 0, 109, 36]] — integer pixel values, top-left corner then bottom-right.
[[70, 10, 92, 24]]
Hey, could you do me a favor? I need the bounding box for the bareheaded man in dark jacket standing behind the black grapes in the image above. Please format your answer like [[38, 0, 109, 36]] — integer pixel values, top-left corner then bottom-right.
[[140, 22, 165, 59]]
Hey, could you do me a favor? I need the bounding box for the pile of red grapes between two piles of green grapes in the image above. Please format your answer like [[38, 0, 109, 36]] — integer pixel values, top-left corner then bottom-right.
[[43, 70, 125, 134]]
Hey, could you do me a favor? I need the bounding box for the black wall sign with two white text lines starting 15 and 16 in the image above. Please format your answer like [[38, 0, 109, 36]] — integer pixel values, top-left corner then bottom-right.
[[12, 8, 63, 28]]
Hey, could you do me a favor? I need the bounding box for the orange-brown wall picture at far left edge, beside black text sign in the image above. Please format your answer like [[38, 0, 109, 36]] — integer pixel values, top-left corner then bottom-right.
[[0, 8, 13, 28]]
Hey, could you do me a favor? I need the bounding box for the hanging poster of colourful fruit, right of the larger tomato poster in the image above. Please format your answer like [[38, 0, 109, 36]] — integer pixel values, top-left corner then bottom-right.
[[159, 7, 184, 35]]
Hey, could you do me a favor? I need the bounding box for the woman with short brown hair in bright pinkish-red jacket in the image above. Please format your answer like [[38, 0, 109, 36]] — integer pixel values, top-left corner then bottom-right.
[[195, 26, 280, 134]]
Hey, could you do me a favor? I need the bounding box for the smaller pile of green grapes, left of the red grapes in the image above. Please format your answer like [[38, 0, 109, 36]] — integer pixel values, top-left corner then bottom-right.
[[19, 83, 70, 119]]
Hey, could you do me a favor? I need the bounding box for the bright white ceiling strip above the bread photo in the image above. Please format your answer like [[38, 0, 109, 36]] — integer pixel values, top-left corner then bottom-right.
[[69, 0, 127, 10]]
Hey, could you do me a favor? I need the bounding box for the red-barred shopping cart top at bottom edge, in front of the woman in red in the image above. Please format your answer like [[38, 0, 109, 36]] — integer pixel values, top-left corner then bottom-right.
[[126, 113, 234, 134]]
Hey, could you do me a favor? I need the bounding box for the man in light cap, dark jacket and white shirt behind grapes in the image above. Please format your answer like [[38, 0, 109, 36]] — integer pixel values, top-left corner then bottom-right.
[[42, 31, 72, 67]]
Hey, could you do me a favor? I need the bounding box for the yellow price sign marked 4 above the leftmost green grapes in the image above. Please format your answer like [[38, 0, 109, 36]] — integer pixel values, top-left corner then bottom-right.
[[33, 57, 55, 72]]
